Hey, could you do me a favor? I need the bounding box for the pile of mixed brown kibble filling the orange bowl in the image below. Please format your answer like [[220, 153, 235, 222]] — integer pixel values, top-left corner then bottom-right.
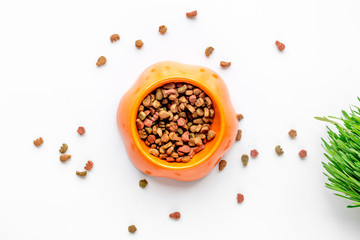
[[136, 83, 216, 163]]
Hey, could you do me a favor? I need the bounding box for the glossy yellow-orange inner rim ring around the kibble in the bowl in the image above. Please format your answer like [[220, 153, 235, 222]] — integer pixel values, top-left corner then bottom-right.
[[130, 76, 226, 170]]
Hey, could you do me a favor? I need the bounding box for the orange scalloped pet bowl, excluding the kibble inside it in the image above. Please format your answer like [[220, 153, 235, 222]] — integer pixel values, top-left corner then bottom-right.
[[117, 62, 237, 181]]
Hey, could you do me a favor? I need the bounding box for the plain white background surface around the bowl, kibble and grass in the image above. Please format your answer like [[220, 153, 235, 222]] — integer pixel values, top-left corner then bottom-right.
[[0, 0, 360, 240]]
